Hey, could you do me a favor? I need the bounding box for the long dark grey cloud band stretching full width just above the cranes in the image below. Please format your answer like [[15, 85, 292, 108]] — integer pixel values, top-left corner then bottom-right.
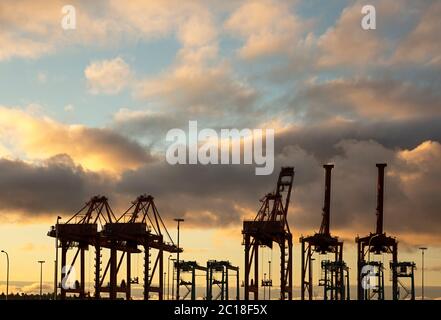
[[0, 132, 441, 242]]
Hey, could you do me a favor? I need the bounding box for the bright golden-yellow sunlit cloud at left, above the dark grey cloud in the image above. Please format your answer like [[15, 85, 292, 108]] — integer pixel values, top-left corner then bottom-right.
[[0, 107, 152, 174]]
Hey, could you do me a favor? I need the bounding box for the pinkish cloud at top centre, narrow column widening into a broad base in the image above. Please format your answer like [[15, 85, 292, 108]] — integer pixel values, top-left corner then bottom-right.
[[129, 2, 257, 120]]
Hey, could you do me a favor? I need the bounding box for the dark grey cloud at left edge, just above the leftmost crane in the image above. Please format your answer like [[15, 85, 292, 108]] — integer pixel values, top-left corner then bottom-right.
[[0, 155, 111, 216]]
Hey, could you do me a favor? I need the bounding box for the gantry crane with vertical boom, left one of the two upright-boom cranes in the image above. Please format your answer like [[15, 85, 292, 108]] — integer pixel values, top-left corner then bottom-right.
[[300, 164, 349, 300]]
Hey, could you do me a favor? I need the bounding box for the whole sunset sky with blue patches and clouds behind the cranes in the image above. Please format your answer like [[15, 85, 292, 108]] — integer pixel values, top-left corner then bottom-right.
[[0, 0, 441, 296]]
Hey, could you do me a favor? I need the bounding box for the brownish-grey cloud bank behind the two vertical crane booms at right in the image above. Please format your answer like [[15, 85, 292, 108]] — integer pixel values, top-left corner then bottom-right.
[[286, 140, 441, 236]]
